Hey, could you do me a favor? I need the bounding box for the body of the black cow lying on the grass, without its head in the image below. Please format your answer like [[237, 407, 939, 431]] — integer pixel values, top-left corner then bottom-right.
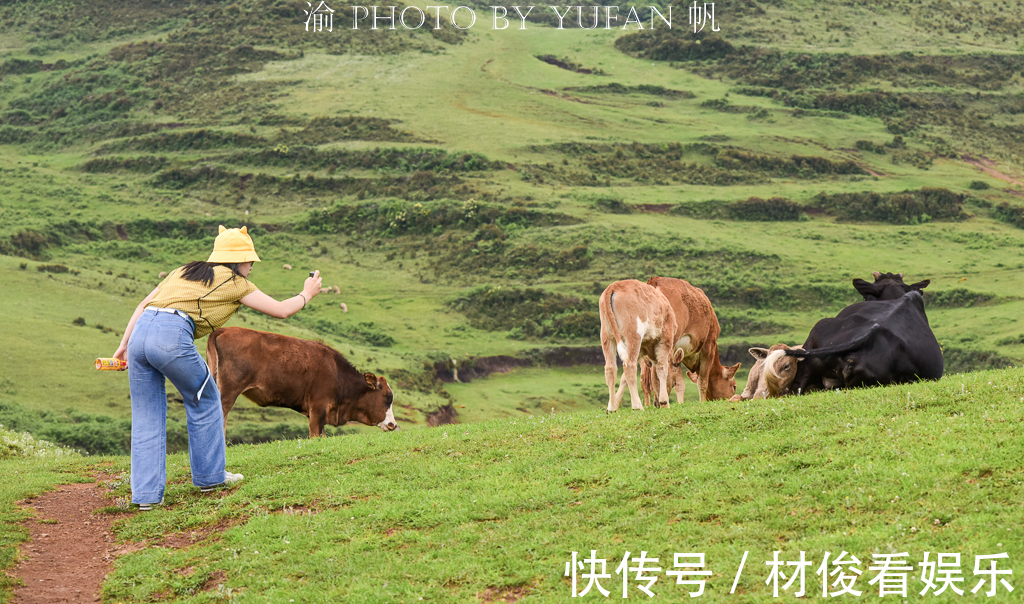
[[786, 290, 942, 393]]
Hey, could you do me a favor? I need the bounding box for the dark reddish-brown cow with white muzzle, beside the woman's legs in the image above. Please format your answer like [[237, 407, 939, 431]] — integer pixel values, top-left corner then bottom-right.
[[206, 328, 398, 438]]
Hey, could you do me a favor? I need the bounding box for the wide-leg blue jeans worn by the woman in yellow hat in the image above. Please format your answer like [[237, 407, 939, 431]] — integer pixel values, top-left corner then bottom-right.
[[128, 310, 225, 504]]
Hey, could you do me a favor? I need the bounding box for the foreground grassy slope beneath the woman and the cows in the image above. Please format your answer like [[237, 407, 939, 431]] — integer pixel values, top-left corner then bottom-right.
[[0, 369, 1024, 603]]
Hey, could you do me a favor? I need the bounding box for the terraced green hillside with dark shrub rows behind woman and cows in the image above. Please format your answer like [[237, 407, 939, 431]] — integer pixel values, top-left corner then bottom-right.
[[0, 0, 1024, 452]]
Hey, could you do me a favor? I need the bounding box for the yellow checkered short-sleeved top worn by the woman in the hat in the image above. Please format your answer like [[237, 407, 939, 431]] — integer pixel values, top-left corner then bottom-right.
[[150, 266, 258, 340]]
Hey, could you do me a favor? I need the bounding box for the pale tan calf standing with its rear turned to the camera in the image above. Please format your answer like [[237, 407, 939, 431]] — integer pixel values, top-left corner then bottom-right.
[[598, 279, 678, 413]]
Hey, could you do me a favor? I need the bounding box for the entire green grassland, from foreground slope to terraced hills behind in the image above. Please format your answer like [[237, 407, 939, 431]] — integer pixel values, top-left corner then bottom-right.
[[0, 0, 1024, 602]]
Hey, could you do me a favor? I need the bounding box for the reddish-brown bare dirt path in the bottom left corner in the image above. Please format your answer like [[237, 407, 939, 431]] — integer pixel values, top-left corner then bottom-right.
[[7, 476, 130, 604]]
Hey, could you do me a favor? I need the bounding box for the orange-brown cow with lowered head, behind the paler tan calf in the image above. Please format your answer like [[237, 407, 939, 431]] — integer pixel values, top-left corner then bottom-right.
[[647, 276, 740, 403]]
